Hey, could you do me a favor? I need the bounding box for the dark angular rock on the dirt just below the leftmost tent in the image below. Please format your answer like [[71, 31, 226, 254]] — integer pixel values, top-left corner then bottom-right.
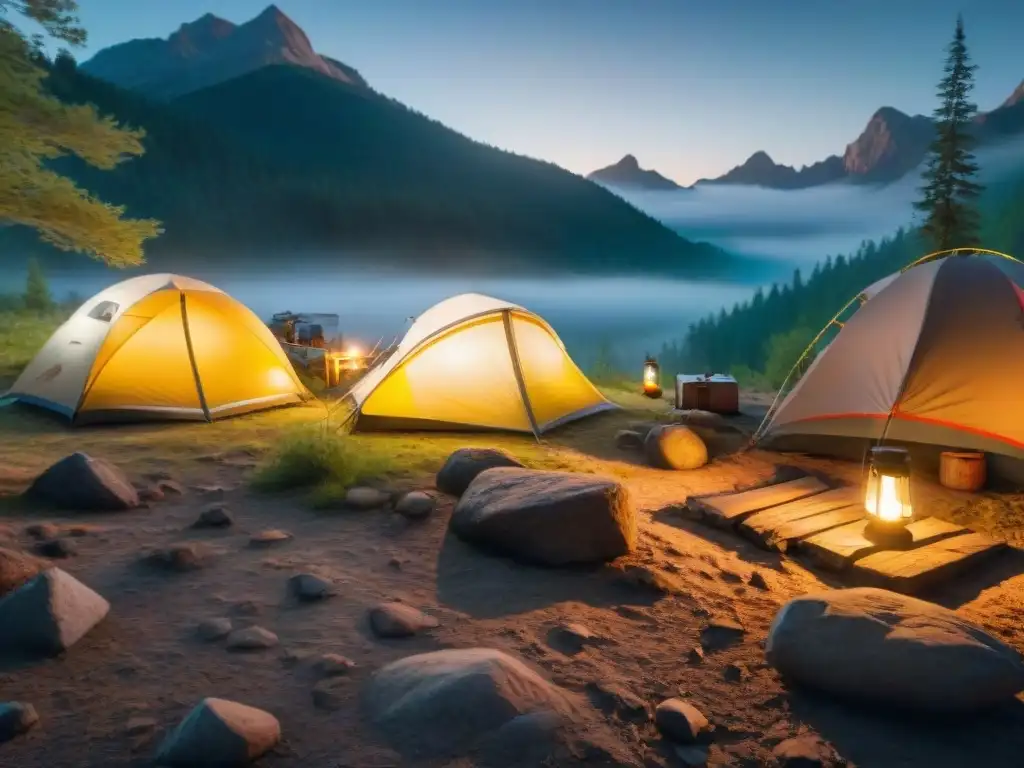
[[26, 453, 140, 512]]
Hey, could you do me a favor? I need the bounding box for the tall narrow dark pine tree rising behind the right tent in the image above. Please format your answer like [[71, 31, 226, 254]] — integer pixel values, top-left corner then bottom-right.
[[914, 16, 982, 251]]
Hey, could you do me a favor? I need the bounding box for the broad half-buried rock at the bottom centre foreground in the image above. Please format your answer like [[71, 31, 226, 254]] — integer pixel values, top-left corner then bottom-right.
[[365, 648, 578, 765]]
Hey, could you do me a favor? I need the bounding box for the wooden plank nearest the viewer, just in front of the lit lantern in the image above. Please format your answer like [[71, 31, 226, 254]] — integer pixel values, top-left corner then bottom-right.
[[851, 532, 1007, 594]]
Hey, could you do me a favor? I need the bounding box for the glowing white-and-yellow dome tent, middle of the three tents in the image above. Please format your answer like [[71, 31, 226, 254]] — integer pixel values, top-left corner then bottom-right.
[[349, 294, 615, 436]]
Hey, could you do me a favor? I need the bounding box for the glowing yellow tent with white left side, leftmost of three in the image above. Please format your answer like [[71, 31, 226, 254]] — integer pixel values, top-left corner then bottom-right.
[[8, 274, 308, 424]]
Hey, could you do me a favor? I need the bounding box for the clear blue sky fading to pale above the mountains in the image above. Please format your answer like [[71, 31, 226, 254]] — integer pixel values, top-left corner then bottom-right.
[[25, 0, 1024, 183]]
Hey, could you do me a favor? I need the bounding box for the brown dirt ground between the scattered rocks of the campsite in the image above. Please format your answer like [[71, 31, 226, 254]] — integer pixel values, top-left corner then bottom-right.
[[0, 393, 1024, 768]]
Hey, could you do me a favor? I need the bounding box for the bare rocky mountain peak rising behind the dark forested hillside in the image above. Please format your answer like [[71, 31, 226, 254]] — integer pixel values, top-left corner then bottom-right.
[[82, 4, 369, 99]]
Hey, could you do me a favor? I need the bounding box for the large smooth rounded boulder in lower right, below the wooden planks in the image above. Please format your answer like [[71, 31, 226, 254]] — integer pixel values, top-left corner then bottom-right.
[[765, 588, 1024, 713]]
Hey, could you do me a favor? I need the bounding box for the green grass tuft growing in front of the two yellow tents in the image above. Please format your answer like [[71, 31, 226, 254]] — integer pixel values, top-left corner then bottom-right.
[[253, 425, 395, 506]]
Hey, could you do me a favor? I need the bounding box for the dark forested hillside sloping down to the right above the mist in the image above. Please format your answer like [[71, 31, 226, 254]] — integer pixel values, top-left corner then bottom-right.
[[0, 57, 730, 276]]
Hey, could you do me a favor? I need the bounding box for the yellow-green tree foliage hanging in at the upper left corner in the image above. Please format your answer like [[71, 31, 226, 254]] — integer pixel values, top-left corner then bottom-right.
[[0, 0, 160, 265]]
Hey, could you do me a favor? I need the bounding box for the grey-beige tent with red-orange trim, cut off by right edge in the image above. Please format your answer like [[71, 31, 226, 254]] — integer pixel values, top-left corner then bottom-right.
[[757, 255, 1024, 477]]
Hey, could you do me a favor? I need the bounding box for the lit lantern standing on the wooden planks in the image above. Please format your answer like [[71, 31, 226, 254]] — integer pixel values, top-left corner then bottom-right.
[[864, 446, 913, 547]]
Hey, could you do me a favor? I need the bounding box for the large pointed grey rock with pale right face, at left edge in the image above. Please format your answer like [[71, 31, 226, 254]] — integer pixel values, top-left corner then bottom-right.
[[0, 568, 111, 656]]
